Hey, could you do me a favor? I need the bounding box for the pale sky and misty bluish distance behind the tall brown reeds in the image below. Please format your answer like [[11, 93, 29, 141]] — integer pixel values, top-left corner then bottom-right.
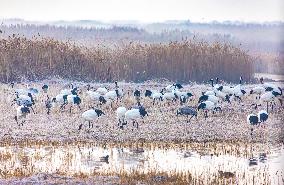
[[0, 0, 284, 81]]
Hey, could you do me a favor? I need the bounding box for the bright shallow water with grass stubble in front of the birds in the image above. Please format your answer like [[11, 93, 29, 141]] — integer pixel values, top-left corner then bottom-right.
[[0, 144, 284, 184]]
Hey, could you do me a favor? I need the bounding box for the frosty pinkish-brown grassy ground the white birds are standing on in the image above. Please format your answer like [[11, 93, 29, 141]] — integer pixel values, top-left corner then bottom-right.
[[0, 81, 284, 143]]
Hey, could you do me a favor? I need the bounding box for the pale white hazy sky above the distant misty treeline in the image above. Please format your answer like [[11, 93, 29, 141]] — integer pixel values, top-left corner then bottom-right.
[[0, 0, 284, 22]]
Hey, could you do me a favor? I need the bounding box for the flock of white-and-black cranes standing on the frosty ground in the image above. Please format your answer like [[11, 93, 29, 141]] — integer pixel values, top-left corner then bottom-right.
[[7, 77, 283, 137]]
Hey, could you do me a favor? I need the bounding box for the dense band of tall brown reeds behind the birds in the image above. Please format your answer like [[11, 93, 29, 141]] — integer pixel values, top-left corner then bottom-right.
[[0, 35, 253, 82]]
